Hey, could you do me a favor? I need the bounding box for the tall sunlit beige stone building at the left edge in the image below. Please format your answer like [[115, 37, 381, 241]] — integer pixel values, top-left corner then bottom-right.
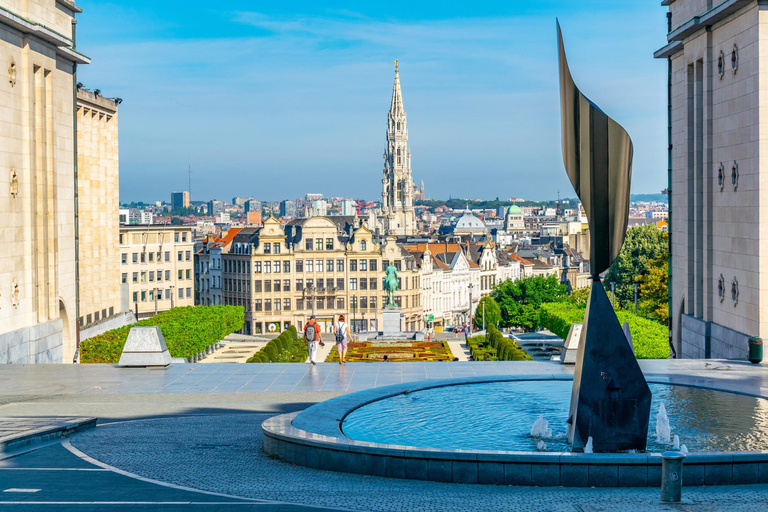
[[0, 0, 90, 363]]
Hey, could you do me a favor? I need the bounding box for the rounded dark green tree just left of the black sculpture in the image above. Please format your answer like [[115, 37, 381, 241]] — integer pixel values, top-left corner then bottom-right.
[[492, 275, 568, 331]]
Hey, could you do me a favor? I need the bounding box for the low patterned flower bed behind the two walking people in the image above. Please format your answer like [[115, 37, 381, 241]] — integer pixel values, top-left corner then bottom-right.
[[326, 341, 453, 363]]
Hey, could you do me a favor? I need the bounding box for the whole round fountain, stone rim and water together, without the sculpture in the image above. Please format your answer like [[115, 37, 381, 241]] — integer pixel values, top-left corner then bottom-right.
[[262, 375, 768, 487]]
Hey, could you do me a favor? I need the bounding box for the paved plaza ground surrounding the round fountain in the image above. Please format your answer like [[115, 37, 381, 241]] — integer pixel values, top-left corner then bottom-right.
[[0, 360, 768, 512]]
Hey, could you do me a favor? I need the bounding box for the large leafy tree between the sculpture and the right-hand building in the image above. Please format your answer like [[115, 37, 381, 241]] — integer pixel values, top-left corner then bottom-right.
[[603, 225, 669, 309]]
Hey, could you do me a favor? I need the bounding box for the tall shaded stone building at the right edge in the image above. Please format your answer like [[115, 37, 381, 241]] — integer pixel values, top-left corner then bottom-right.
[[655, 0, 768, 358]]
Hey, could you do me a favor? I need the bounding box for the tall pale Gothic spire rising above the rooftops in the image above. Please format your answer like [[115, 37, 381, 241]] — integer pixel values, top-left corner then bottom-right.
[[370, 62, 417, 236]]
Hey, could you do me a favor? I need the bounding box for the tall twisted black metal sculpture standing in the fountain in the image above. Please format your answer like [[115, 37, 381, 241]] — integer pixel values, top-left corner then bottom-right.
[[557, 23, 651, 452]]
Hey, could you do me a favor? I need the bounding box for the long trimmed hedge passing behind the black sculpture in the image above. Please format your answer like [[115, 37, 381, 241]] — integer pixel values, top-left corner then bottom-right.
[[539, 302, 669, 359]]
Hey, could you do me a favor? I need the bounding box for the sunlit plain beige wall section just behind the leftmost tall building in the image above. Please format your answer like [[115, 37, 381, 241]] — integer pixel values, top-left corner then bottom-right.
[[77, 90, 121, 327]]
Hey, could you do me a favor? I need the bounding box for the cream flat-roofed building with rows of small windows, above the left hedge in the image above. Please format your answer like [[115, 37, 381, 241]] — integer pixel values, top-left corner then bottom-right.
[[120, 224, 195, 319]]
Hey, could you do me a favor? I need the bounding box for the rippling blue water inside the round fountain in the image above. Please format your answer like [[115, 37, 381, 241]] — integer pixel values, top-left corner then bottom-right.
[[343, 381, 768, 452]]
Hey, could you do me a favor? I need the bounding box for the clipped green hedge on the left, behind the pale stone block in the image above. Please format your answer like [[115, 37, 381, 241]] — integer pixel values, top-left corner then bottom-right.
[[80, 306, 245, 364]]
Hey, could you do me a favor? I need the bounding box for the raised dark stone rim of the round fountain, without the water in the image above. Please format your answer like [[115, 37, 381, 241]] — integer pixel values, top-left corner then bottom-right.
[[262, 375, 768, 487]]
